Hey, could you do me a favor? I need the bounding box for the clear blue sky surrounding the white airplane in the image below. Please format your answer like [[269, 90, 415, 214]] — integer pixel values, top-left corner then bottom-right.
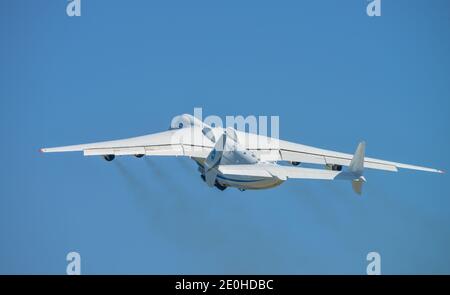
[[0, 0, 450, 274]]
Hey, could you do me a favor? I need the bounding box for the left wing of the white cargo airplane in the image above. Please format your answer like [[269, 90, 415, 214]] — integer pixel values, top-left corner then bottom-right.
[[41, 128, 213, 158]]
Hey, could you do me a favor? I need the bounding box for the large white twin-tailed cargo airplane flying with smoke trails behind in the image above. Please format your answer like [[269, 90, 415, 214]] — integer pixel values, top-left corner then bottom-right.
[[41, 114, 443, 194]]
